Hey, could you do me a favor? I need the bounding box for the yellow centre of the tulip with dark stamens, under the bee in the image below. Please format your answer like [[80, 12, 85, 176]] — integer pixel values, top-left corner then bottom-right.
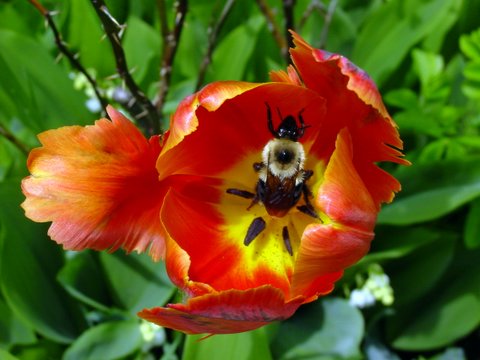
[[219, 143, 325, 271]]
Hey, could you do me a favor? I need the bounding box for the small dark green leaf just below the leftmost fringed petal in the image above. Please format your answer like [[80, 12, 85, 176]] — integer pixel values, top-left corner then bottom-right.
[[58, 251, 111, 311]]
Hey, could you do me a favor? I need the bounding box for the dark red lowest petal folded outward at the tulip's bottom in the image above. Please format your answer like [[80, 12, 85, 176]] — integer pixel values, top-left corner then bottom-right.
[[138, 285, 303, 334]]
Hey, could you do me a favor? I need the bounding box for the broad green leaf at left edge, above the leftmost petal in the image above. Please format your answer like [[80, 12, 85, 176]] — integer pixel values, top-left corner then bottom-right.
[[0, 30, 92, 135]]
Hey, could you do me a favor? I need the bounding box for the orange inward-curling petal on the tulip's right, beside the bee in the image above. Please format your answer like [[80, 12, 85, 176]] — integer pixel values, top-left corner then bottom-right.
[[292, 129, 377, 297]]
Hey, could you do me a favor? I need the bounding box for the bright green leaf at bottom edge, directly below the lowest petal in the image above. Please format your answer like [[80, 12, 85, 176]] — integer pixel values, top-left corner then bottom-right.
[[182, 329, 272, 360]]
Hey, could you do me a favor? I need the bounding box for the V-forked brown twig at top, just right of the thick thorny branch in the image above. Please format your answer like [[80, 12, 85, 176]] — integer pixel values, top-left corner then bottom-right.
[[154, 0, 188, 113]]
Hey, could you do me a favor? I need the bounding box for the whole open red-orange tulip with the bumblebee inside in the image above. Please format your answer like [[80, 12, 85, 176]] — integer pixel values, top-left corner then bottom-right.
[[23, 34, 408, 334]]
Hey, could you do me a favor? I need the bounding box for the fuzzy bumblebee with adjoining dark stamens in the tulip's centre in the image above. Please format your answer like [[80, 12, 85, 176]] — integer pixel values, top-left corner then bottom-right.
[[226, 103, 318, 255]]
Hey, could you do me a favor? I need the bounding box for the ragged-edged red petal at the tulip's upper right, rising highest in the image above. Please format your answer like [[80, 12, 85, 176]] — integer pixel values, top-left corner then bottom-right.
[[291, 33, 409, 207]]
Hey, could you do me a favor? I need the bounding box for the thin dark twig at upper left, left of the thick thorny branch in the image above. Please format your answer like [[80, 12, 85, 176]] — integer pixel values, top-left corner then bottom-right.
[[29, 0, 108, 109]]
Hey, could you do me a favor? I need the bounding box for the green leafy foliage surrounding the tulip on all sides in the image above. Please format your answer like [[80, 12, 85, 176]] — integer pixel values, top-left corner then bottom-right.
[[0, 0, 480, 360]]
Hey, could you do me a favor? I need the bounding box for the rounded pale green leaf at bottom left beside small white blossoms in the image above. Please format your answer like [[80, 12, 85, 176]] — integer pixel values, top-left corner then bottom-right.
[[63, 320, 142, 360]]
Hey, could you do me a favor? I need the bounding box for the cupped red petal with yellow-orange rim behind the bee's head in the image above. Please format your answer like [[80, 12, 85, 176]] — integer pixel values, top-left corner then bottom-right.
[[157, 83, 325, 186]]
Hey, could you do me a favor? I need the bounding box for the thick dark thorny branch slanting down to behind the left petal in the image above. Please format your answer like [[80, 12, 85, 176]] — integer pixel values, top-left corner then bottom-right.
[[91, 0, 160, 135]]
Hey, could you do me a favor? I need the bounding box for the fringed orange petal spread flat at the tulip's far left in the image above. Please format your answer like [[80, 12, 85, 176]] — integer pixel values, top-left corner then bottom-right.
[[22, 107, 164, 259]]
